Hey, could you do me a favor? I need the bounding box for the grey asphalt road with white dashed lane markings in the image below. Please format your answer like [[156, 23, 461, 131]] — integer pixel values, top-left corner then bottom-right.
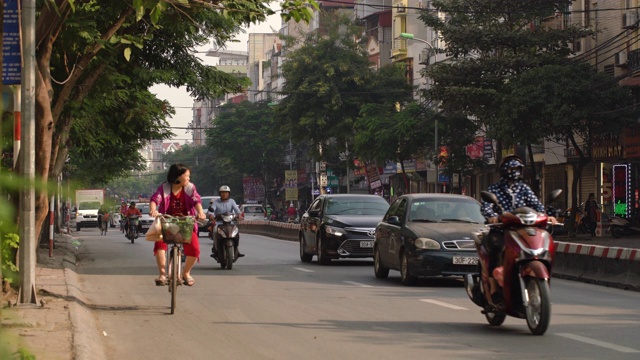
[[63, 229, 640, 359]]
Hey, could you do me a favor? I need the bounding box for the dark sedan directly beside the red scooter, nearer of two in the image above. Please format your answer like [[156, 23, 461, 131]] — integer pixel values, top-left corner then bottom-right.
[[373, 194, 485, 285]]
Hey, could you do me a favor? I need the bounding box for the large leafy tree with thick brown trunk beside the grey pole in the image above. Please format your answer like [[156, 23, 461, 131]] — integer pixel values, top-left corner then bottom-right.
[[28, 0, 317, 243]]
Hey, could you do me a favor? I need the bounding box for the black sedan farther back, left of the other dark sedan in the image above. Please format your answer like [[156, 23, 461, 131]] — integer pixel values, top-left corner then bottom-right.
[[298, 194, 389, 264]]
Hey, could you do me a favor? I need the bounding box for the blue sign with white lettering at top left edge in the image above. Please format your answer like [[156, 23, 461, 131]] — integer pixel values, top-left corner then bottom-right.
[[2, 0, 22, 85]]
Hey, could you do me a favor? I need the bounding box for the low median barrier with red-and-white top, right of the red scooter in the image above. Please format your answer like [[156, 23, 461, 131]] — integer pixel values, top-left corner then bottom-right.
[[553, 242, 640, 291]]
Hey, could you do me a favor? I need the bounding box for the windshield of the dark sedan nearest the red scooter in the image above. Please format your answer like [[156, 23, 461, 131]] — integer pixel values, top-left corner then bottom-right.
[[409, 198, 485, 224]]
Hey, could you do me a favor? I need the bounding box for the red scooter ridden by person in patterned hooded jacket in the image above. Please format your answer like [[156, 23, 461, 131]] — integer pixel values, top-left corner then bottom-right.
[[464, 190, 562, 335]]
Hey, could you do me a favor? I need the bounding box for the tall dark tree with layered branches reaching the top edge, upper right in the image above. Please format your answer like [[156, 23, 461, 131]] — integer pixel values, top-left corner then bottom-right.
[[420, 0, 593, 194]]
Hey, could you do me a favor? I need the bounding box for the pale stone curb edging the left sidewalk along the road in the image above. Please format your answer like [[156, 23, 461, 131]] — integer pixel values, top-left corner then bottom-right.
[[58, 234, 107, 360]]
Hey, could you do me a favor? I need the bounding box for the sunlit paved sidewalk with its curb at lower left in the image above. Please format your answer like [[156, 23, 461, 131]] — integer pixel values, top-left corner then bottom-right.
[[0, 234, 105, 360]]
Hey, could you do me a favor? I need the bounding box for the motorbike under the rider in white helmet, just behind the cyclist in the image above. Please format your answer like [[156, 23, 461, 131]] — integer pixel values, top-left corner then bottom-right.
[[213, 213, 240, 270]]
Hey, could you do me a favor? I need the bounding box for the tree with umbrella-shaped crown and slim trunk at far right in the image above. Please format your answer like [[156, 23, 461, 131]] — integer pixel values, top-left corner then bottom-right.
[[502, 61, 636, 231]]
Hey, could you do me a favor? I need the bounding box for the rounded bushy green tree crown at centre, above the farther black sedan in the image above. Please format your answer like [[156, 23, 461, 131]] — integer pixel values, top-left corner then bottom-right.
[[275, 11, 372, 157]]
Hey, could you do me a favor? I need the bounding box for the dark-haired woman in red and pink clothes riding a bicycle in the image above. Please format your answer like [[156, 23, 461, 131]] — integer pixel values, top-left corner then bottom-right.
[[149, 164, 206, 286]]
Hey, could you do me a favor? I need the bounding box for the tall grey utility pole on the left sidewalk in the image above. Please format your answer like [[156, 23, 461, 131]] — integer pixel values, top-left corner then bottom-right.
[[16, 0, 38, 304]]
